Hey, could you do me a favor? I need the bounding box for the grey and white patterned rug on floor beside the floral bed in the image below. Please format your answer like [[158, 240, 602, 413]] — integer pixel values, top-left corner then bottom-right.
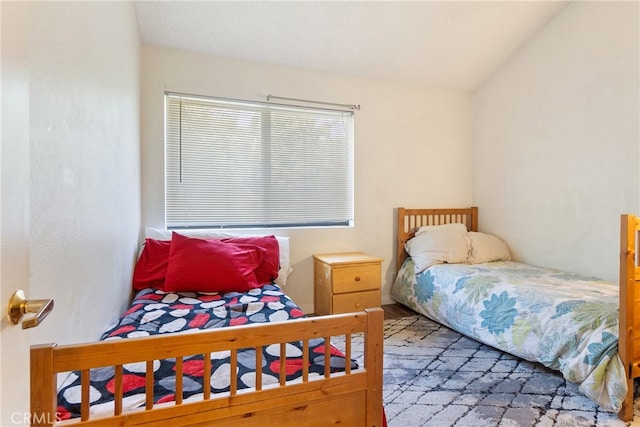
[[360, 315, 640, 427]]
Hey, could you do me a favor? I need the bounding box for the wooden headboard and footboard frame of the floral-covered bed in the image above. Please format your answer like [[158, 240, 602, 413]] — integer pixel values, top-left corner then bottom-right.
[[397, 207, 640, 422]]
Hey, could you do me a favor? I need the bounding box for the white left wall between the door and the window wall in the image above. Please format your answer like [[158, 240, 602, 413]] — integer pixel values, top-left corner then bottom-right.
[[29, 2, 140, 343]]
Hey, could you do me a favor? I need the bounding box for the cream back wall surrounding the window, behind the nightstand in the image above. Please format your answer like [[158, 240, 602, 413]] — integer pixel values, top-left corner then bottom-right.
[[141, 46, 472, 312]]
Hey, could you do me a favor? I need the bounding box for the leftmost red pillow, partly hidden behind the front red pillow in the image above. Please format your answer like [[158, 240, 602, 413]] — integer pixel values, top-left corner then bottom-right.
[[133, 239, 171, 291]]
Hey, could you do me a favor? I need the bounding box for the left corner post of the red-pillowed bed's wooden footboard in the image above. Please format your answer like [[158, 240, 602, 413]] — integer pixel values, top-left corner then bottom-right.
[[30, 344, 59, 426]]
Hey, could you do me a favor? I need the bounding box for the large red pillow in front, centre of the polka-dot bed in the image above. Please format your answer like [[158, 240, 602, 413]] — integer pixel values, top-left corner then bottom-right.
[[164, 232, 264, 292]]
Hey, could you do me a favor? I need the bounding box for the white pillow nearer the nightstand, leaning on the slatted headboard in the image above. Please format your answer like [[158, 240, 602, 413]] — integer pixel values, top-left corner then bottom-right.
[[405, 224, 469, 274]]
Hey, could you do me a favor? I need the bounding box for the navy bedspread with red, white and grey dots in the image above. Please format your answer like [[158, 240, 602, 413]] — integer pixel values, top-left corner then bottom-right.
[[58, 284, 357, 419]]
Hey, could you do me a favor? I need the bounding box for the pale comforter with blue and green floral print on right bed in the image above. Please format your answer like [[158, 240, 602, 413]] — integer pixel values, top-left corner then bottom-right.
[[391, 259, 627, 412]]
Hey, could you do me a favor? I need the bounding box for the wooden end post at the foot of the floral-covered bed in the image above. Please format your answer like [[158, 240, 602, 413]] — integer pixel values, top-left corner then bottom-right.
[[618, 214, 638, 421]]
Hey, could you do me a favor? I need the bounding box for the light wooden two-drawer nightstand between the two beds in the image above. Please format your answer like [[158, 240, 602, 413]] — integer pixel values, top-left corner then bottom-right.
[[313, 252, 383, 315]]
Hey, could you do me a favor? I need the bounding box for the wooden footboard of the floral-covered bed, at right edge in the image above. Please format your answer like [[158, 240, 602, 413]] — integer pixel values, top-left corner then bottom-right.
[[618, 214, 640, 421]]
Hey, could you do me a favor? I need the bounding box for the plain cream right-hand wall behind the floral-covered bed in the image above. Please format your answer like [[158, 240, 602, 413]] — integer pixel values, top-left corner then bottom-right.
[[473, 2, 640, 280]]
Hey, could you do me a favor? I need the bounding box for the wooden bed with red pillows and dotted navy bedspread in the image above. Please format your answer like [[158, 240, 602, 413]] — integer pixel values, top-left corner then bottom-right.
[[31, 232, 384, 427]]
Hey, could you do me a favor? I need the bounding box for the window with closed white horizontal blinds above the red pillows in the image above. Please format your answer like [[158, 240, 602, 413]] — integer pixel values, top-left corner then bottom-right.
[[164, 92, 355, 230]]
